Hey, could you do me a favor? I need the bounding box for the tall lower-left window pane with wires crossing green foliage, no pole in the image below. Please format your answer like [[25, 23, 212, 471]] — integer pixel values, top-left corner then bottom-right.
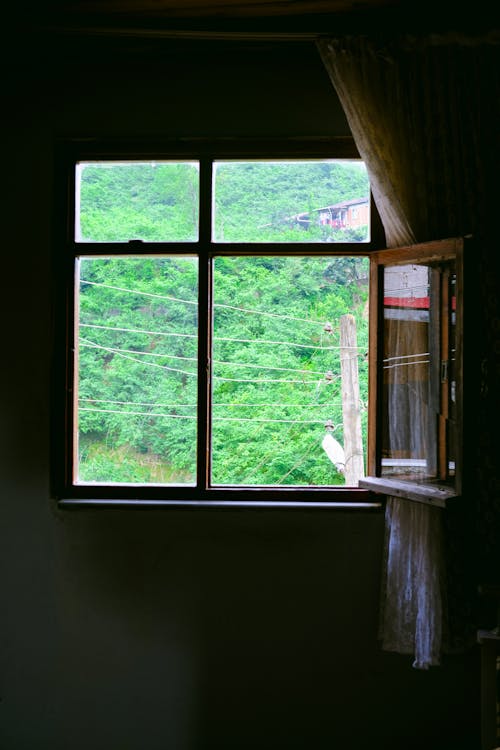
[[74, 256, 198, 485]]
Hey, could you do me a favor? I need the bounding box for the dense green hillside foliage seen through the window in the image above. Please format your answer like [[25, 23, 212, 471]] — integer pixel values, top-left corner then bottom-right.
[[75, 162, 369, 486]]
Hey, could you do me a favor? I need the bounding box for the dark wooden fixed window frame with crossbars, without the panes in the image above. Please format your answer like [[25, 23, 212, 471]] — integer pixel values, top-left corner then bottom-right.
[[51, 137, 443, 509]]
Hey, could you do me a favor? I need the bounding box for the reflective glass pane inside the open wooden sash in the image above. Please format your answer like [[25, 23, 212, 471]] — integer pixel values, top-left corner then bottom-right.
[[381, 261, 456, 483]]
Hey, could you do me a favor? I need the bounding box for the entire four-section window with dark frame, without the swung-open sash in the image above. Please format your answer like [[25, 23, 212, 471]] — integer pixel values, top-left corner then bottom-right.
[[53, 141, 462, 505]]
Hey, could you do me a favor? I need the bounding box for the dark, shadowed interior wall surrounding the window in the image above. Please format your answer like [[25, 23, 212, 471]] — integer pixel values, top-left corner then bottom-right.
[[0, 36, 479, 750]]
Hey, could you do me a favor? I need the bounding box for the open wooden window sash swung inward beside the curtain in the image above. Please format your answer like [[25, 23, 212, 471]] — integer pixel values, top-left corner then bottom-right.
[[359, 238, 465, 506]]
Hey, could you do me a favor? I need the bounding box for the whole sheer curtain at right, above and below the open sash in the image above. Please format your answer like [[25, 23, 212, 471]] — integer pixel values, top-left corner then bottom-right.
[[317, 33, 498, 669]]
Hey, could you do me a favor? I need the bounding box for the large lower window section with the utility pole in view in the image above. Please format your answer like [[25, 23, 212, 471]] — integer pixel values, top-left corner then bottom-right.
[[211, 256, 368, 487]]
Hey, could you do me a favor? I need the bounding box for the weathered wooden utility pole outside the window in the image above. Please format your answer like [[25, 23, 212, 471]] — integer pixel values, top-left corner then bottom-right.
[[340, 314, 365, 487]]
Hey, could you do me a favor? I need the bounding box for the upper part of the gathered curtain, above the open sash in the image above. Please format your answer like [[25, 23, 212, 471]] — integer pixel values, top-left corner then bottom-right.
[[317, 33, 500, 247]]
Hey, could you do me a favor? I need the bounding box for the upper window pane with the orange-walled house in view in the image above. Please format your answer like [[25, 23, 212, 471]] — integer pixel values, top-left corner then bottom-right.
[[212, 159, 370, 242]]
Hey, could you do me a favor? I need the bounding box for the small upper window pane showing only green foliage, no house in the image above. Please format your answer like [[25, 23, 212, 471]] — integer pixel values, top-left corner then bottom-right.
[[75, 161, 199, 242]]
